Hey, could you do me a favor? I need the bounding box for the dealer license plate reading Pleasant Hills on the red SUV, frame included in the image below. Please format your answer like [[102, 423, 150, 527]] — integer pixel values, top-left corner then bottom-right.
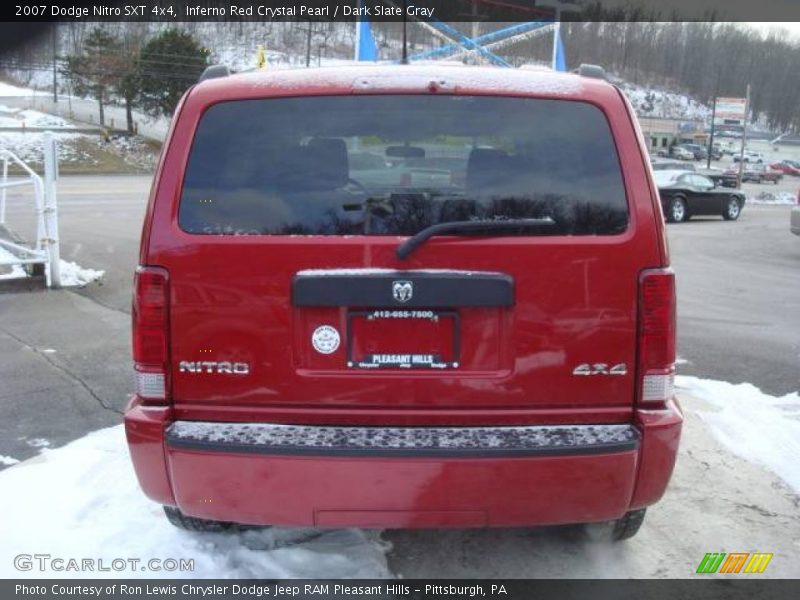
[[347, 309, 460, 369]]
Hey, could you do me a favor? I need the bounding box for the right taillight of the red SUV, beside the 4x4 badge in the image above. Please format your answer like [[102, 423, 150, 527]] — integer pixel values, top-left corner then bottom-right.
[[638, 269, 677, 405]]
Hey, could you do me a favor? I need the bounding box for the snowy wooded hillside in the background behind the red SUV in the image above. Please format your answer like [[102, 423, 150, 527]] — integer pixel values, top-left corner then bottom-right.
[[0, 21, 800, 131]]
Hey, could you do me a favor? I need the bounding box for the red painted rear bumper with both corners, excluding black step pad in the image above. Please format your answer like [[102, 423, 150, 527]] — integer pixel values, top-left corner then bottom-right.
[[125, 400, 683, 527]]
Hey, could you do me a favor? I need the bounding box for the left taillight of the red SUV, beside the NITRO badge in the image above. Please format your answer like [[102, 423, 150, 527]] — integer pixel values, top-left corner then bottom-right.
[[132, 267, 169, 403]]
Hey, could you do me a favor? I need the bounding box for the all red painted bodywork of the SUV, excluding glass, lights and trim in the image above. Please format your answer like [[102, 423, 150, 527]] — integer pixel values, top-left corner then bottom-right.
[[125, 66, 682, 527]]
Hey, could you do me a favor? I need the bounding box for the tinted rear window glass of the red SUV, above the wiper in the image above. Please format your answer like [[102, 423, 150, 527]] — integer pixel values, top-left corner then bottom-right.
[[179, 95, 628, 235]]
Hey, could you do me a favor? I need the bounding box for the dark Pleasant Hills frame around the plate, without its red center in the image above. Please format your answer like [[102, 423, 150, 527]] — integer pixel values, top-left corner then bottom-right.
[[345, 308, 461, 371]]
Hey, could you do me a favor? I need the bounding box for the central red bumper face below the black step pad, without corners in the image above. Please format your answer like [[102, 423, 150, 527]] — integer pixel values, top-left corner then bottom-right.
[[168, 449, 637, 527]]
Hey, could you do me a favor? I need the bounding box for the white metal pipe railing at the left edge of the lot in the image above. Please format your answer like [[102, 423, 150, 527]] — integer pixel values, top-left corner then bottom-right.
[[0, 132, 61, 287]]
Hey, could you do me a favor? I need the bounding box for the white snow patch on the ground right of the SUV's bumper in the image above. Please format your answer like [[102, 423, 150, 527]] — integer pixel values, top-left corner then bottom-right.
[[675, 376, 800, 492]]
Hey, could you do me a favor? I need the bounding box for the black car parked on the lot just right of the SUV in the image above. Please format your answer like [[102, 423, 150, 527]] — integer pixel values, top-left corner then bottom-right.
[[655, 171, 745, 223]]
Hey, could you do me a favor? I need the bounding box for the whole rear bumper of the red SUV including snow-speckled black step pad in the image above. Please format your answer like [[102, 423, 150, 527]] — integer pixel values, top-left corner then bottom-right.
[[125, 400, 682, 527]]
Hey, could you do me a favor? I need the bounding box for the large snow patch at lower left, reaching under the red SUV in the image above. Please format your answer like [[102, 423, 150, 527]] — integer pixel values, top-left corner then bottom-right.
[[0, 425, 391, 579]]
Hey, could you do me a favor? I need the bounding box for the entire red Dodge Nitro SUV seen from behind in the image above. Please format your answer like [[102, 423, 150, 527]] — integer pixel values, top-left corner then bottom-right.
[[125, 65, 682, 539]]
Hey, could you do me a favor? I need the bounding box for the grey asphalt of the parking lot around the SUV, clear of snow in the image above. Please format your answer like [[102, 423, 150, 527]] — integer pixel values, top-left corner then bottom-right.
[[0, 176, 800, 577]]
